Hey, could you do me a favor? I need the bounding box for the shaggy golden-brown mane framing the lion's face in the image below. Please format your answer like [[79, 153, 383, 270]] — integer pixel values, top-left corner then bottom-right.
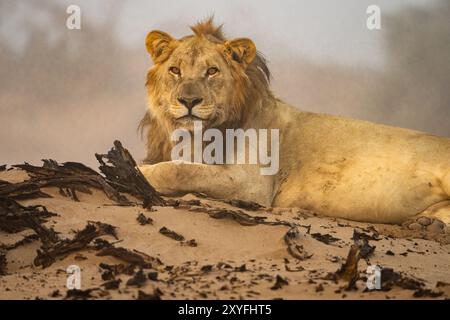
[[138, 17, 274, 164]]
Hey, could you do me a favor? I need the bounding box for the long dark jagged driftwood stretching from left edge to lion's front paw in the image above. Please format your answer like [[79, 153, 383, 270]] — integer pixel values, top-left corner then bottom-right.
[[0, 141, 165, 208]]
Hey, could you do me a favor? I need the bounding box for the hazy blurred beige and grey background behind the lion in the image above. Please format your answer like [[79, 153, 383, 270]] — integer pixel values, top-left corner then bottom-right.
[[0, 0, 450, 167]]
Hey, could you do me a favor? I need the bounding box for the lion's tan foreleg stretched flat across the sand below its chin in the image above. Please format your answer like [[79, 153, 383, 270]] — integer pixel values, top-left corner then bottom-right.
[[139, 162, 274, 206]]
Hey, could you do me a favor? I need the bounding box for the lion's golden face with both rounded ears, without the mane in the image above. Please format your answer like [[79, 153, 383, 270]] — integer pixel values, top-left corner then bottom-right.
[[147, 31, 256, 130]]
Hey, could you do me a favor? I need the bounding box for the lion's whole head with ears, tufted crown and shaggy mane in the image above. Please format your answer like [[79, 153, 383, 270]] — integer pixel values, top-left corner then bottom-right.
[[141, 19, 271, 162]]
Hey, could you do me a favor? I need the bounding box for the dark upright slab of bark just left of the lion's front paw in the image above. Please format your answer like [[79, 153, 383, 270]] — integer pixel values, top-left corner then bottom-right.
[[95, 140, 165, 207]]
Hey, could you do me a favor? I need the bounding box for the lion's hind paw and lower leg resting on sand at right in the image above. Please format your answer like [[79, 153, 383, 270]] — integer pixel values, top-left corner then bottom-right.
[[402, 200, 450, 234]]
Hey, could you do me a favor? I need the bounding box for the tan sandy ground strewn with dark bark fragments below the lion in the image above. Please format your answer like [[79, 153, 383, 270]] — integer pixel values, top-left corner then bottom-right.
[[0, 170, 450, 299]]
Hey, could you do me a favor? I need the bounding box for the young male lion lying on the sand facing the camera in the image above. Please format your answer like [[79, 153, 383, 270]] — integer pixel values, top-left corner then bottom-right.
[[140, 20, 450, 231]]
